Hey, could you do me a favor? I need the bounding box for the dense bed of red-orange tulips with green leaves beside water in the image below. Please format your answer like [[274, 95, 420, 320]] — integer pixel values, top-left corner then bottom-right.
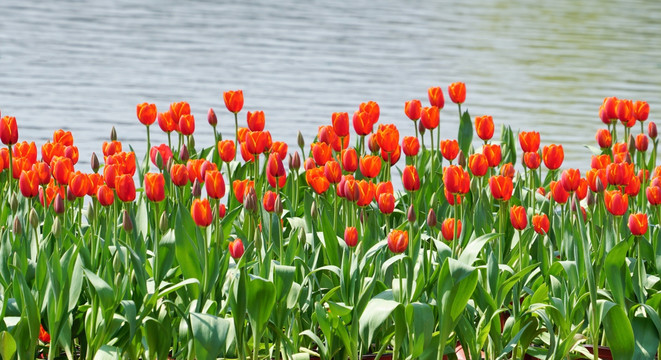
[[0, 83, 661, 360]]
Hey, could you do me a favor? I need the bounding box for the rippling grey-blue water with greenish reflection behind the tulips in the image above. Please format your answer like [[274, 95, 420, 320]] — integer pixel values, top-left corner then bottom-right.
[[0, 0, 661, 172]]
